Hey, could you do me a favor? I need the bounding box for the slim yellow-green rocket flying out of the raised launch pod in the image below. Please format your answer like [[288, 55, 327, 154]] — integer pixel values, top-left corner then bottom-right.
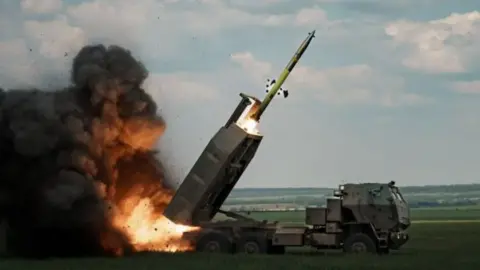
[[252, 30, 315, 121]]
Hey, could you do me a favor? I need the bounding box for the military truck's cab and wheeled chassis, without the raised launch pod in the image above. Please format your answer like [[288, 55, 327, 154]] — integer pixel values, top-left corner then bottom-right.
[[185, 182, 410, 254]]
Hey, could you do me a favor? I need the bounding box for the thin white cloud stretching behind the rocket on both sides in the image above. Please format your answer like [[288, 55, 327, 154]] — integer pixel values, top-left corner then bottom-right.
[[231, 52, 426, 106]]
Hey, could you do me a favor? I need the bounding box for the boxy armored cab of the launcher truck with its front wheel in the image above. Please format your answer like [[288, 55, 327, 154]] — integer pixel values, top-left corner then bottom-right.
[[300, 182, 410, 253]]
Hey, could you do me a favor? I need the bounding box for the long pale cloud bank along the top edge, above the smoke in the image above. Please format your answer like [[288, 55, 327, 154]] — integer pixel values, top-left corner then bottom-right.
[[12, 0, 338, 62]]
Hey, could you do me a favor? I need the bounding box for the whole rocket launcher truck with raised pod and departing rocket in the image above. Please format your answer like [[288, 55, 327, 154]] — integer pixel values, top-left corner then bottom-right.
[[164, 31, 410, 254]]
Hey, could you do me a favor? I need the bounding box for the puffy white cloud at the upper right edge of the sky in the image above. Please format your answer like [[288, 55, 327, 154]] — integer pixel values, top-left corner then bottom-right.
[[385, 11, 480, 73]]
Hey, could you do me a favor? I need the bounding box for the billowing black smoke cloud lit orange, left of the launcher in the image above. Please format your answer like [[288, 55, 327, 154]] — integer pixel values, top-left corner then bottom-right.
[[0, 45, 169, 256]]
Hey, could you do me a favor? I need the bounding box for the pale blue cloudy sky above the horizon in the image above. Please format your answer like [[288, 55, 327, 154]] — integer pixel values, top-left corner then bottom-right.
[[0, 0, 480, 187]]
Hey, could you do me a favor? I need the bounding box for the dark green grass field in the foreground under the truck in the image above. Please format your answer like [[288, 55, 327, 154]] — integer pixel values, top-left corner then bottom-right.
[[0, 209, 480, 270]]
